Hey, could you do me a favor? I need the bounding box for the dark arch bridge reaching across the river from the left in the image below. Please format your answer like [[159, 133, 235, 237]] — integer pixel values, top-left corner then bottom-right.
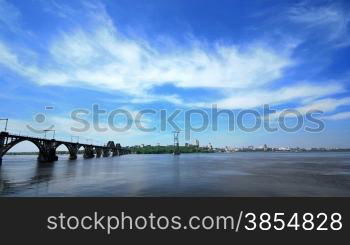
[[0, 132, 130, 165]]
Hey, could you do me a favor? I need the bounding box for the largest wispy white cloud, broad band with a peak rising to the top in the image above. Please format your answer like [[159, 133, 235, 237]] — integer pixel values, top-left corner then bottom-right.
[[0, 1, 293, 97]]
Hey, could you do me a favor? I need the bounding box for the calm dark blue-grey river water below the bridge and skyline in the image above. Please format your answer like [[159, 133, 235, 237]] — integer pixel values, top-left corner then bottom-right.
[[0, 152, 350, 196]]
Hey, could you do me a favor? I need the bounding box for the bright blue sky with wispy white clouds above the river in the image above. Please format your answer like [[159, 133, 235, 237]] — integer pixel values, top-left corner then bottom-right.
[[0, 0, 350, 149]]
